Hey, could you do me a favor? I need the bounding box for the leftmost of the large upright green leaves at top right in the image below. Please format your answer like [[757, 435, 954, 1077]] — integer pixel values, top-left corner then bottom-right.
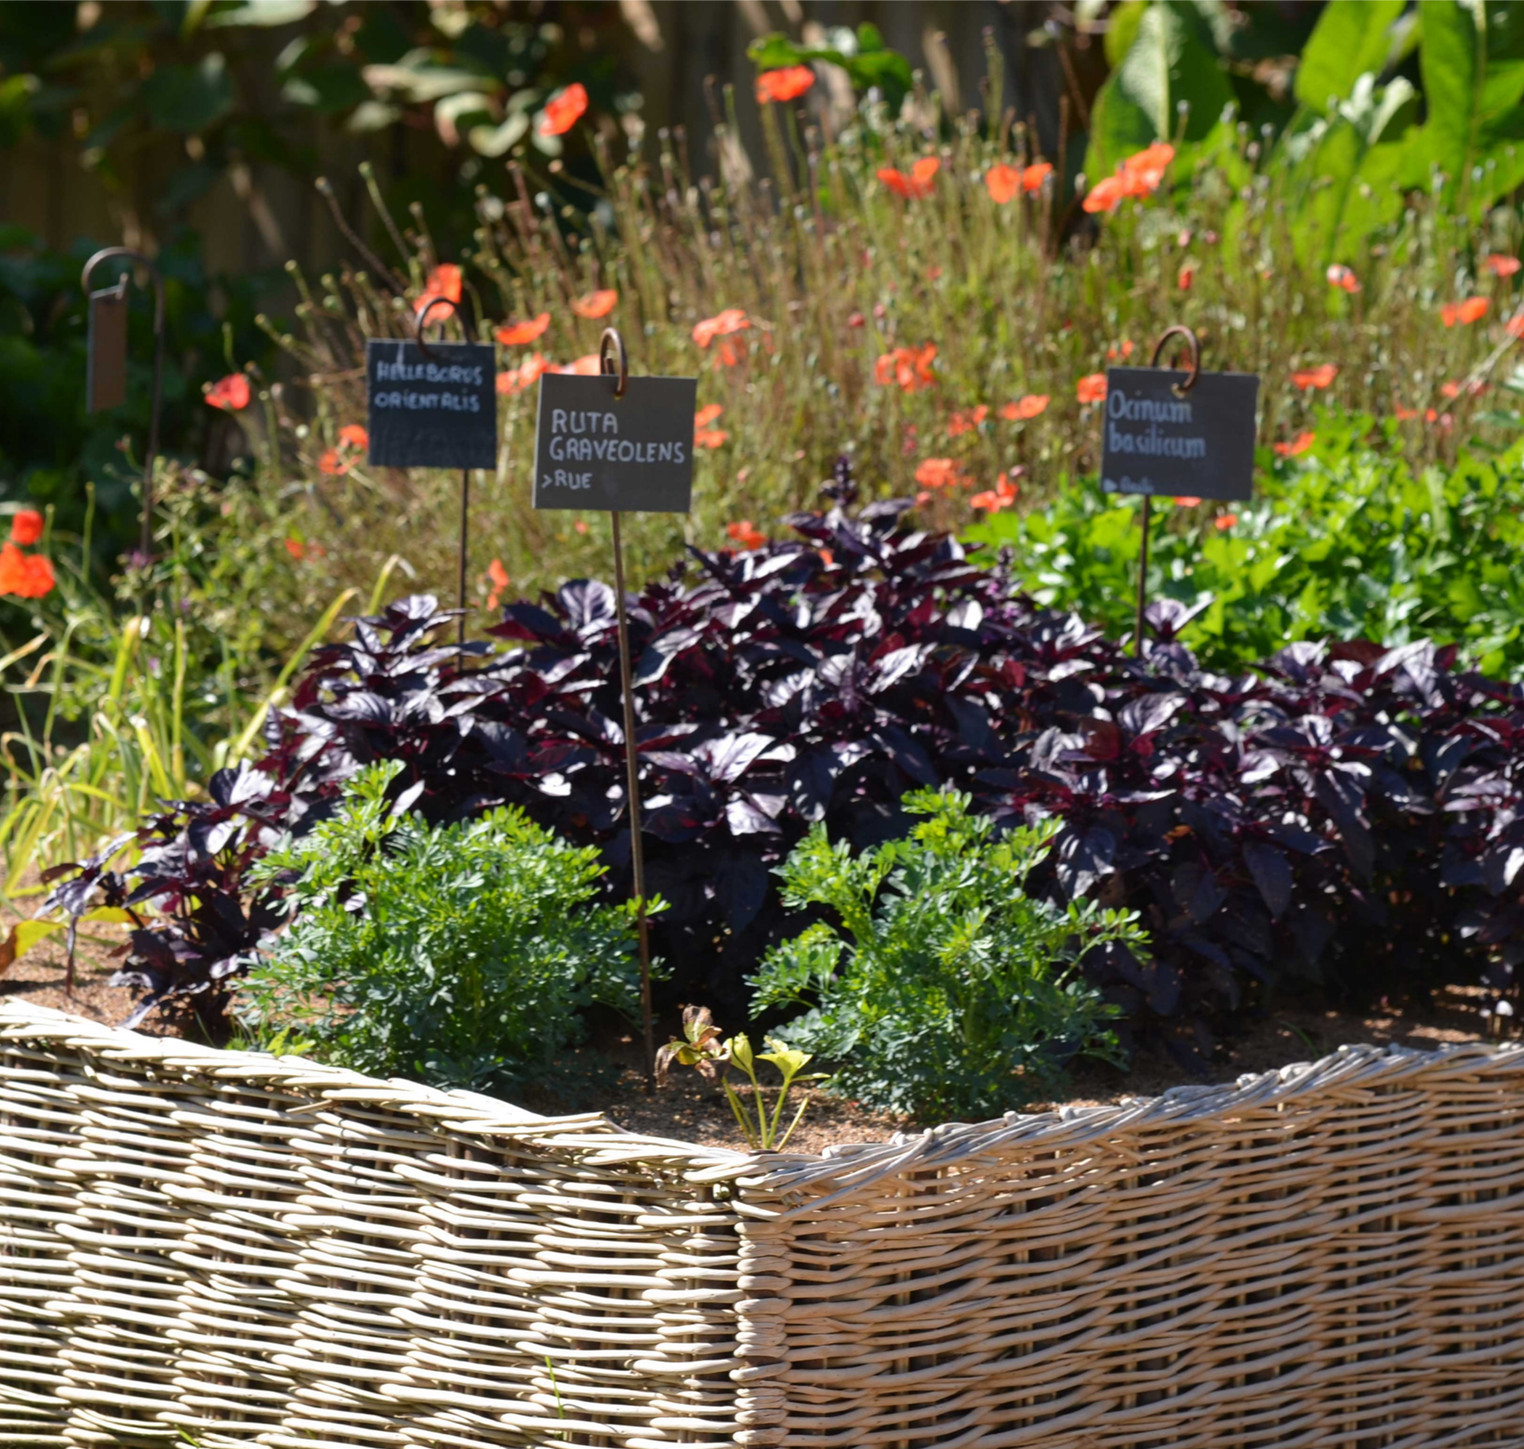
[[1085, 0, 1233, 180]]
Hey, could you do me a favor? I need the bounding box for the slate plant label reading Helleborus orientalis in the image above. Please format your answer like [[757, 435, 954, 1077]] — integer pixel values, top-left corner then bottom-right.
[[366, 337, 497, 468]]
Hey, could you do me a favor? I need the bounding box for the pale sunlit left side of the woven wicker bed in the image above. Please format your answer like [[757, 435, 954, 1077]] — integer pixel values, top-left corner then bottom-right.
[[0, 1004, 747, 1449]]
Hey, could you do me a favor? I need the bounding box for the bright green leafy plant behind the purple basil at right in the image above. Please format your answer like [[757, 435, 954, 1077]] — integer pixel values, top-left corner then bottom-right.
[[969, 413, 1524, 678]]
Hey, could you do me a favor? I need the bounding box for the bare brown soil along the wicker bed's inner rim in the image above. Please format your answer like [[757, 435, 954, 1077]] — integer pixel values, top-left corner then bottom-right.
[[0, 911, 1490, 1152]]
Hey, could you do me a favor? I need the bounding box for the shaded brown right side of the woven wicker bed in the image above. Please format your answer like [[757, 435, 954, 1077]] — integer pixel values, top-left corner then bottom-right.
[[742, 1047, 1524, 1449]]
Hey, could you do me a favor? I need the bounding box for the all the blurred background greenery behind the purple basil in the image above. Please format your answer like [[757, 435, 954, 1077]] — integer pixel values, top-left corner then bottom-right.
[[0, 0, 1524, 902]]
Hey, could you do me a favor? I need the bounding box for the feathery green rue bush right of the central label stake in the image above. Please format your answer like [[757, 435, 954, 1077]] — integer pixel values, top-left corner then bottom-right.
[[753, 789, 1143, 1118]]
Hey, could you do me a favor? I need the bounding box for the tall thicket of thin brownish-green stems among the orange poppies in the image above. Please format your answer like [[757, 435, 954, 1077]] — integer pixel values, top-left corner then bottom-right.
[[243, 62, 1519, 602]]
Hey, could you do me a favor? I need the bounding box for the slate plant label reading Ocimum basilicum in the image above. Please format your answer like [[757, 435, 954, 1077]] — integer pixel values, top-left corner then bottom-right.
[[1100, 367, 1259, 503]]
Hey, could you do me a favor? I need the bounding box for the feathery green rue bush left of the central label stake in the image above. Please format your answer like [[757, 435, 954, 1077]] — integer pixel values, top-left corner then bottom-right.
[[236, 762, 646, 1089]]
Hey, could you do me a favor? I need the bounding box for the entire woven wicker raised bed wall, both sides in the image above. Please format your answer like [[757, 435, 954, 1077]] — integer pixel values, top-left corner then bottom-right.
[[0, 1004, 1524, 1449]]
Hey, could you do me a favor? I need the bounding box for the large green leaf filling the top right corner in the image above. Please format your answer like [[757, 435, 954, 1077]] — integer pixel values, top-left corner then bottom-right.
[[1407, 0, 1524, 210]]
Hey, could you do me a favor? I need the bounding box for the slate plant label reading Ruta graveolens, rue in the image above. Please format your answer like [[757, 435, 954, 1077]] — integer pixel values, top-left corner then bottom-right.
[[535, 372, 698, 513]]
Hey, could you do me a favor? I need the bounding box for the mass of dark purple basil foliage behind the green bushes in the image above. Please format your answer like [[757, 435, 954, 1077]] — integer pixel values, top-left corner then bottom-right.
[[55, 463, 1524, 1062]]
